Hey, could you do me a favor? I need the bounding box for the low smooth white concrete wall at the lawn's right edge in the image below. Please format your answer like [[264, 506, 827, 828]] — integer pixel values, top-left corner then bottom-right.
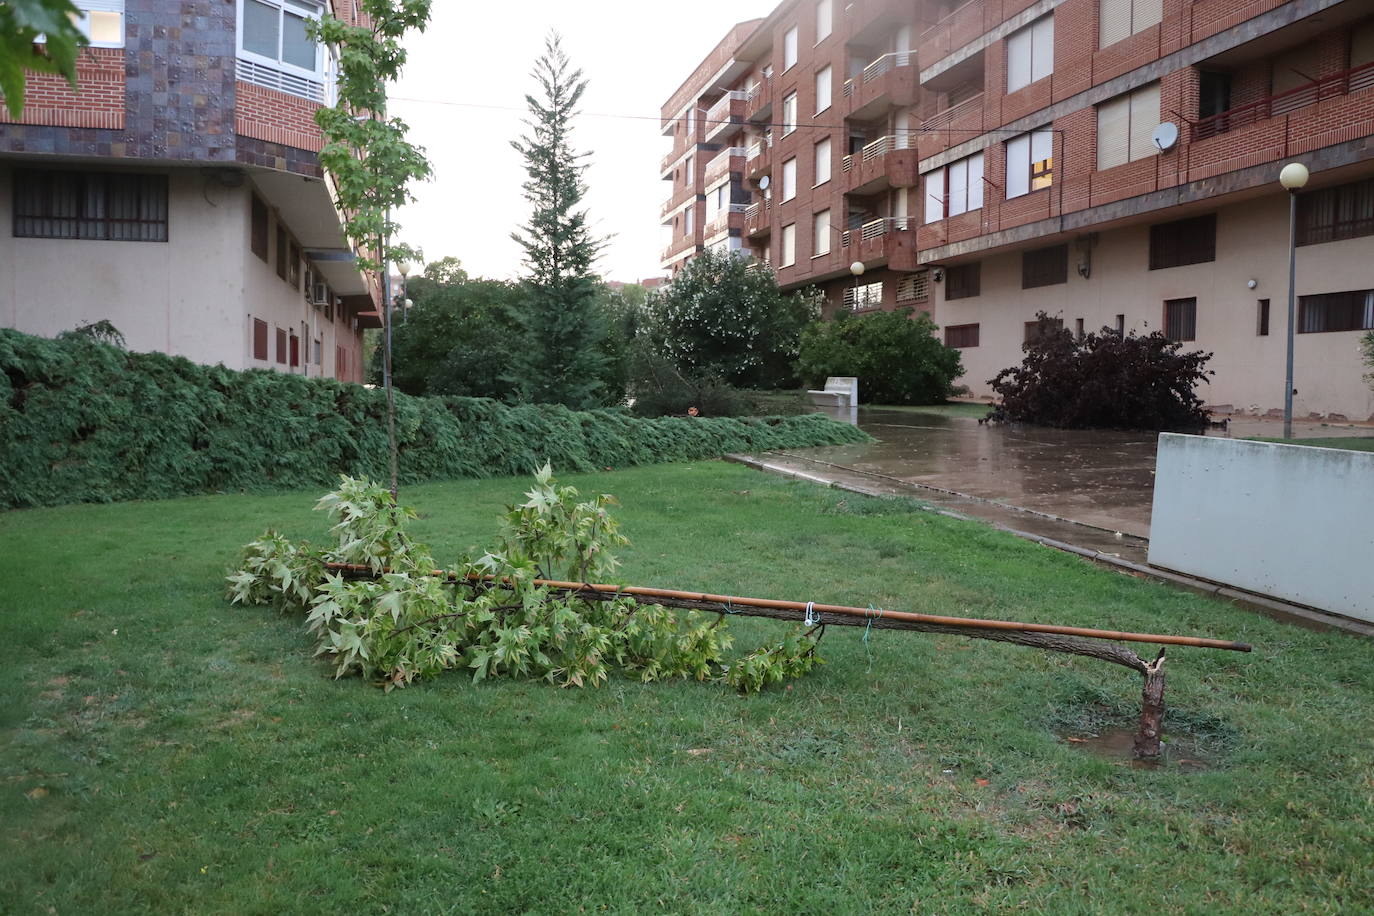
[[1150, 433, 1374, 621]]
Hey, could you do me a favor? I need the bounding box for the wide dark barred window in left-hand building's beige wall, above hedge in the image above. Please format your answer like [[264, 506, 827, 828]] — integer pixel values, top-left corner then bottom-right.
[[14, 169, 168, 242]]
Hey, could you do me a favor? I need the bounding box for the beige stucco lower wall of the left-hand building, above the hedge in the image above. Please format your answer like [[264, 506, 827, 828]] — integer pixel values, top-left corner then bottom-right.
[[0, 163, 359, 376]]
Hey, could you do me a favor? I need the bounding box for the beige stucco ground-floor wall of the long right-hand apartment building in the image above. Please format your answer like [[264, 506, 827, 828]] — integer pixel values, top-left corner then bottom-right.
[[934, 195, 1374, 420]]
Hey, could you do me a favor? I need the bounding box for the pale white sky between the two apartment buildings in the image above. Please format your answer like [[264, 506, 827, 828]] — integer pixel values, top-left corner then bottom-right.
[[390, 0, 776, 282]]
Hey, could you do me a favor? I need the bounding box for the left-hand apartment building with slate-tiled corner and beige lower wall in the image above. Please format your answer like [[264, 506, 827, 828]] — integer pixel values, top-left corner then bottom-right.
[[0, 0, 381, 382]]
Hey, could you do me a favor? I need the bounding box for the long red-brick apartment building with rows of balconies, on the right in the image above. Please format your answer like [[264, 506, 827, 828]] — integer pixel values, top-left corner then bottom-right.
[[664, 0, 1374, 419]]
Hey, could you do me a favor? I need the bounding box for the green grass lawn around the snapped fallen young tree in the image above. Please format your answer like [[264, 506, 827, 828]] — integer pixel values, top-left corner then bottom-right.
[[0, 461, 1374, 913]]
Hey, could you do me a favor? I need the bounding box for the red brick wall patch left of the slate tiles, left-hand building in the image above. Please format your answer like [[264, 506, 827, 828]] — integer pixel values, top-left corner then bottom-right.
[[0, 48, 125, 130]]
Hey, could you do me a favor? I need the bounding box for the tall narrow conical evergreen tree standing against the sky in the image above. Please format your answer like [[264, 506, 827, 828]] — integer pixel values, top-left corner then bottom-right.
[[510, 33, 606, 408]]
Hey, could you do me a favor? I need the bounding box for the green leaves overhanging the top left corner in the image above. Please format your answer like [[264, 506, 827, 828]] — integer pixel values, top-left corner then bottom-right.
[[0, 0, 88, 118]]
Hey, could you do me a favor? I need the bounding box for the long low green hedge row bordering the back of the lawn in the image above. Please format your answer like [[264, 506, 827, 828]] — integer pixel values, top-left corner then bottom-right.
[[0, 328, 867, 508]]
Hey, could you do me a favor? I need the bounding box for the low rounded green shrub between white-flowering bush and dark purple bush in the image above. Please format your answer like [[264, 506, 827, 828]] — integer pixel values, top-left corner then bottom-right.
[[797, 309, 963, 404]]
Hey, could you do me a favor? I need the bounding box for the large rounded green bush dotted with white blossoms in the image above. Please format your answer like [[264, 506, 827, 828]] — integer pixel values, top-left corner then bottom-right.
[[650, 251, 820, 389]]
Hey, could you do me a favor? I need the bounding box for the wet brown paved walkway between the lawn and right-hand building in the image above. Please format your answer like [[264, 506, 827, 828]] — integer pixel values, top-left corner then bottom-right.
[[753, 408, 1374, 543]]
